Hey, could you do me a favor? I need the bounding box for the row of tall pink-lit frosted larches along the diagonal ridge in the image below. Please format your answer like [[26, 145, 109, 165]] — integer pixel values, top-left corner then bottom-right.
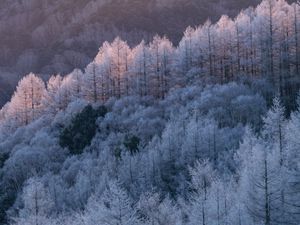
[[0, 0, 300, 130]]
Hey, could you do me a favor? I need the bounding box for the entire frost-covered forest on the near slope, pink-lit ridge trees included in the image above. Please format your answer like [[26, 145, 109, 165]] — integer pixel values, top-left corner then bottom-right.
[[0, 0, 300, 225]]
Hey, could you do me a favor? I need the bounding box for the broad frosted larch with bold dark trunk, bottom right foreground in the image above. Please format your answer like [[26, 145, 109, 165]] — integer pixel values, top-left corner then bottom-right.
[[240, 141, 282, 225]]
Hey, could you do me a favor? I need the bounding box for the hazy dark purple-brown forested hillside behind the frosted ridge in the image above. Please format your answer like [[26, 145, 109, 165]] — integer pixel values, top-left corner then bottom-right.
[[0, 0, 259, 106]]
